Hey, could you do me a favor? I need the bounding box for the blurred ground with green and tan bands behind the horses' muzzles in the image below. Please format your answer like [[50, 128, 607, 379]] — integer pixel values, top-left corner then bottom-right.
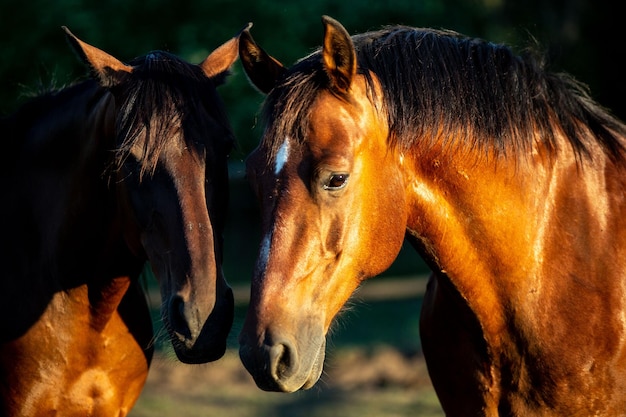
[[130, 276, 443, 417]]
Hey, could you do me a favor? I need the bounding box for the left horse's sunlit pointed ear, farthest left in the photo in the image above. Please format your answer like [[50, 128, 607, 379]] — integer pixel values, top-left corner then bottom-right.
[[62, 26, 133, 87]]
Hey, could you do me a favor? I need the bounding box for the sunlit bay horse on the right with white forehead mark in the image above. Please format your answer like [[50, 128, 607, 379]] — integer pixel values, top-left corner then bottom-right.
[[240, 17, 626, 416]]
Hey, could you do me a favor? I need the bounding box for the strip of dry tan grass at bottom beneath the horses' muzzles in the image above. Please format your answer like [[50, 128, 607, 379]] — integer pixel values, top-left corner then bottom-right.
[[131, 347, 443, 417]]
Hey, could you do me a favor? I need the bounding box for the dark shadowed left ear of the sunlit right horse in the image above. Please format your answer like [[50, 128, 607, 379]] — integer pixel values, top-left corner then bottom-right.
[[239, 27, 286, 94]]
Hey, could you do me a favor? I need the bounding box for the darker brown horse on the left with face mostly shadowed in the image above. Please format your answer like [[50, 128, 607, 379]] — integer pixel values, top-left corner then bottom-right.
[[0, 29, 244, 417]]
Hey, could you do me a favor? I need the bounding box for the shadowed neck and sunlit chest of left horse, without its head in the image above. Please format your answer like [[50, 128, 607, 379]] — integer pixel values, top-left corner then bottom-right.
[[0, 82, 152, 416]]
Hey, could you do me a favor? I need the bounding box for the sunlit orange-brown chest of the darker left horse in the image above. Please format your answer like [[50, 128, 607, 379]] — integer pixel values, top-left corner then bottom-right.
[[0, 288, 148, 416]]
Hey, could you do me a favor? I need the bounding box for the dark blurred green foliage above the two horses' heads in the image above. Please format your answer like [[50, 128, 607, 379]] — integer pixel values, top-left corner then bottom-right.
[[0, 0, 626, 161]]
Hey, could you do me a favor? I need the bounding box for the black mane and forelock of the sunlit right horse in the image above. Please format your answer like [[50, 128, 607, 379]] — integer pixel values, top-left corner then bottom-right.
[[264, 26, 626, 164]]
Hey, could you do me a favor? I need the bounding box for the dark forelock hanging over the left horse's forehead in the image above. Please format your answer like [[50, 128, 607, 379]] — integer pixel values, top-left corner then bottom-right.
[[112, 51, 234, 174]]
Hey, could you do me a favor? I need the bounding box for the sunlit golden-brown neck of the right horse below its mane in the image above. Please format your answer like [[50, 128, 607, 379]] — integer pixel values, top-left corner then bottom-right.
[[406, 135, 626, 334]]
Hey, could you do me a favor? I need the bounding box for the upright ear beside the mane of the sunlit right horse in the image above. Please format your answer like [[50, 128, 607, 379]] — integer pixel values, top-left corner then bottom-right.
[[322, 16, 356, 94]]
